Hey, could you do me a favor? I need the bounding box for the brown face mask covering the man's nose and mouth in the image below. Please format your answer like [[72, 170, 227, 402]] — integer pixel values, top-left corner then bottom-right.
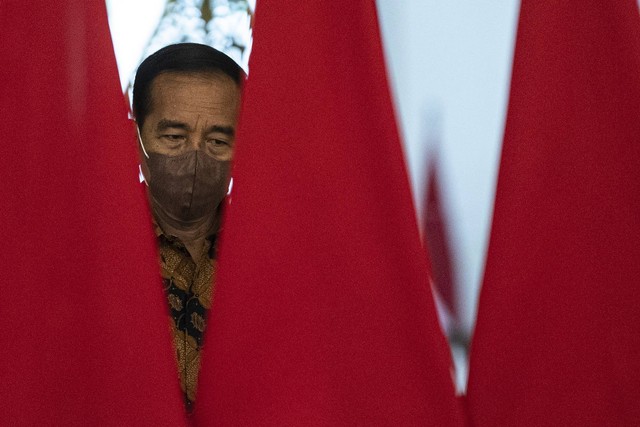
[[147, 150, 230, 223]]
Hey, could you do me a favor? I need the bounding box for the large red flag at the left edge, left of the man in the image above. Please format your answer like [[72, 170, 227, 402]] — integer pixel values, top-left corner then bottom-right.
[[0, 1, 184, 426]]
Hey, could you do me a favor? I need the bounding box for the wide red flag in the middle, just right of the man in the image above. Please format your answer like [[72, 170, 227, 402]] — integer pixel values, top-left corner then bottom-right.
[[194, 0, 461, 426]]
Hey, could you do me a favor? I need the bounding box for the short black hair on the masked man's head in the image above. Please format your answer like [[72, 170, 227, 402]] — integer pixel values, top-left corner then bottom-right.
[[133, 43, 245, 128]]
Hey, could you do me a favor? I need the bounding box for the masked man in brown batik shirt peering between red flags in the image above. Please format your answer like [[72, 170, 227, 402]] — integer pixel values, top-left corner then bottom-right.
[[133, 43, 244, 412]]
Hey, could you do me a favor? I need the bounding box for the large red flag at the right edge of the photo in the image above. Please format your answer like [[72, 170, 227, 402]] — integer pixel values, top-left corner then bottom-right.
[[468, 0, 640, 426]]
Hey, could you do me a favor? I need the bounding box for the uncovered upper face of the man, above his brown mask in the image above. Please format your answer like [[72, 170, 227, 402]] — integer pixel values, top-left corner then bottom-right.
[[140, 72, 241, 177]]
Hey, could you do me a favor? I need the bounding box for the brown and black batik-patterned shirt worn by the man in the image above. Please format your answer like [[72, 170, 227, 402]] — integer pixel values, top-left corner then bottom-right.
[[156, 226, 216, 412]]
